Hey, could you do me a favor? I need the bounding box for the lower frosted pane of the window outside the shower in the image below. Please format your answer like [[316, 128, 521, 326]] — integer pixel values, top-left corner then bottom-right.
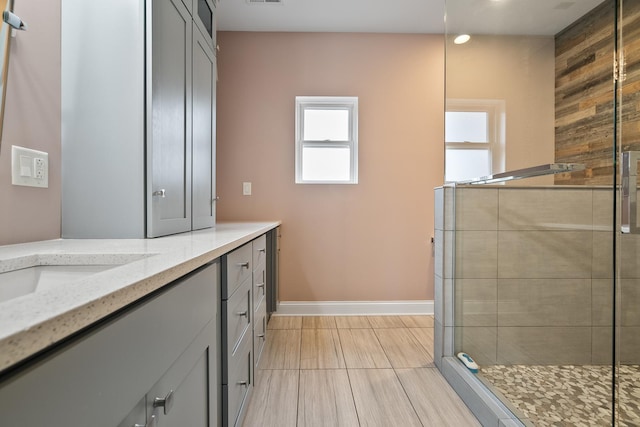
[[302, 147, 351, 181]]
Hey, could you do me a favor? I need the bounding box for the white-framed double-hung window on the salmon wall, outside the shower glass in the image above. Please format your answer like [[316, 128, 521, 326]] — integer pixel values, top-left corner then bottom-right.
[[296, 96, 358, 184]]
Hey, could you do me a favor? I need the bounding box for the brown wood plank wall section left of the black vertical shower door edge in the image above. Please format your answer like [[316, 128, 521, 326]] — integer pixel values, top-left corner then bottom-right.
[[555, 0, 614, 185]]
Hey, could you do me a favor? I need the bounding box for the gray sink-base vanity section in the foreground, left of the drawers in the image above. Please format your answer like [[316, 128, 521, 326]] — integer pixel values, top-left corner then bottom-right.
[[0, 262, 220, 427]]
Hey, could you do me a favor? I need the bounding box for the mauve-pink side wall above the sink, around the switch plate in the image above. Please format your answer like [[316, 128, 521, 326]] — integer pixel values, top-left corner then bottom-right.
[[0, 1, 61, 245]]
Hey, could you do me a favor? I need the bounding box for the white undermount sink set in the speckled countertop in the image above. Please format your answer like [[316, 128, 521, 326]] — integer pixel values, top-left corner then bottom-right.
[[0, 254, 150, 303]]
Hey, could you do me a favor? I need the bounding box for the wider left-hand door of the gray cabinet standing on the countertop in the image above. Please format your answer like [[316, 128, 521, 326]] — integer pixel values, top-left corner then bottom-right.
[[146, 0, 192, 237]]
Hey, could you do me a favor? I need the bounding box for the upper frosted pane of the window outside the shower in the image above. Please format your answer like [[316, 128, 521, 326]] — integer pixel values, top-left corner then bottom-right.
[[303, 109, 349, 141]]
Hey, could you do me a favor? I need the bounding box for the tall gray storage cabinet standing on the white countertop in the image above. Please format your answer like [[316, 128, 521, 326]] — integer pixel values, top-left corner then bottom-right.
[[62, 0, 216, 238]]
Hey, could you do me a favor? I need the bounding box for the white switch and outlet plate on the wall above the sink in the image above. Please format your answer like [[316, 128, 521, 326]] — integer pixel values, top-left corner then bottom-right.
[[11, 145, 49, 188]]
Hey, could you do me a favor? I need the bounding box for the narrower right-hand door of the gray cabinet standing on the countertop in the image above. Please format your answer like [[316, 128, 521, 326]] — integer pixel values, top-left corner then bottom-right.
[[191, 25, 216, 230]]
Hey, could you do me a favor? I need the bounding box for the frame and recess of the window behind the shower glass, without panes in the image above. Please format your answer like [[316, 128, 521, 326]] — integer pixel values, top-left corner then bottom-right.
[[445, 99, 506, 182]]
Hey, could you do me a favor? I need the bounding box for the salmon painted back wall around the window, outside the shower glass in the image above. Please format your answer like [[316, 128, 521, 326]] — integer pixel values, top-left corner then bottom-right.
[[217, 32, 444, 301]]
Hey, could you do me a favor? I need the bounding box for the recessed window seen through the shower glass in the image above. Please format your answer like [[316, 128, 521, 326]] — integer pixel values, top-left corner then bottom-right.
[[444, 99, 505, 182]]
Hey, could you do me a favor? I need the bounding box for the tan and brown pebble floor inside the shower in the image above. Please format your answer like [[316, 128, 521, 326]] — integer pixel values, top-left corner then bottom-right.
[[480, 365, 640, 427]]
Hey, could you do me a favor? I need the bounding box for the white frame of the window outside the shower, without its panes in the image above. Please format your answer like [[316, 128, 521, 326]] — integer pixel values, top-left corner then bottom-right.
[[295, 96, 358, 184]]
